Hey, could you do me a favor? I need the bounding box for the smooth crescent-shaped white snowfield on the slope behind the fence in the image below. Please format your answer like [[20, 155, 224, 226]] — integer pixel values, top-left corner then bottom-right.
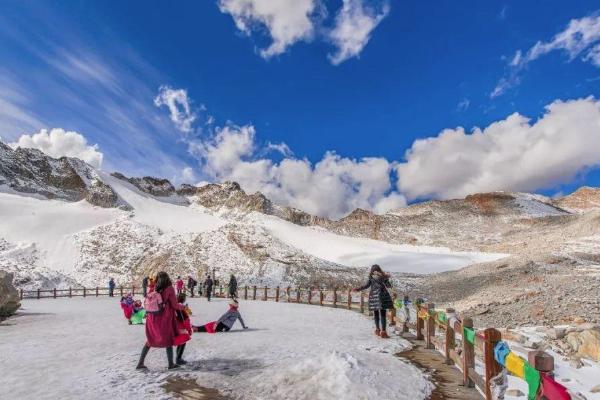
[[254, 215, 506, 274]]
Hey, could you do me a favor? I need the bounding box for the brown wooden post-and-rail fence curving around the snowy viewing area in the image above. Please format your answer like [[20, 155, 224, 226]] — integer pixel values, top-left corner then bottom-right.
[[20, 286, 554, 400]]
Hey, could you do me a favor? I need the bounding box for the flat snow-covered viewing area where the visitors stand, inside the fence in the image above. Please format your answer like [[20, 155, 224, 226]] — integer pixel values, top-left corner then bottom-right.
[[0, 298, 432, 400]]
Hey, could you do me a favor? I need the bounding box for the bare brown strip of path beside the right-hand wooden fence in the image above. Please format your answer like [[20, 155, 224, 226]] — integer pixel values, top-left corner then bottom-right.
[[398, 335, 482, 400]]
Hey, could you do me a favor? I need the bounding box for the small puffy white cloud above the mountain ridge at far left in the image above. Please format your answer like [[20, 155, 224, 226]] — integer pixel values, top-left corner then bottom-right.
[[9, 128, 103, 168]]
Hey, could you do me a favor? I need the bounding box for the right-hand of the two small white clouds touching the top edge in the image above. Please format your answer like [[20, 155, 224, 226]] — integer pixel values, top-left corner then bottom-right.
[[329, 0, 390, 65]]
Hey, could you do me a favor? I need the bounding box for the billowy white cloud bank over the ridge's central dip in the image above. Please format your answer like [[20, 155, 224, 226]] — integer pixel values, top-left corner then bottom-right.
[[191, 125, 406, 218]]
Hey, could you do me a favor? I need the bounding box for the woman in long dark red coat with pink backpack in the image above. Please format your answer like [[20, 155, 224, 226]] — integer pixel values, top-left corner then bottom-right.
[[137, 272, 185, 369]]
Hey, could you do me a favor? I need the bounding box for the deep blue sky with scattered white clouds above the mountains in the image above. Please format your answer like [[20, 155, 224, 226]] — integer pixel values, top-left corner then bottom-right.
[[0, 0, 600, 216]]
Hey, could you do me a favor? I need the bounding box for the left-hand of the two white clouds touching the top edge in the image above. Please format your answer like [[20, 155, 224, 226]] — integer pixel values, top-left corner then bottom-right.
[[219, 0, 320, 58]]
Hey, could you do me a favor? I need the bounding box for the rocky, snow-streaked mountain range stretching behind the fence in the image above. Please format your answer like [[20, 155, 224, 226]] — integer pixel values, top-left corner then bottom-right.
[[0, 143, 596, 288]]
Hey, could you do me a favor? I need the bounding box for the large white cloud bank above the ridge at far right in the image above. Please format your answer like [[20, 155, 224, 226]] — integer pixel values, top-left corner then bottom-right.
[[397, 97, 600, 199]]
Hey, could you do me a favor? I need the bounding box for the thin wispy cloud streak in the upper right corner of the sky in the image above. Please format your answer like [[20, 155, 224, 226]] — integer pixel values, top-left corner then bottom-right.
[[491, 13, 600, 98]]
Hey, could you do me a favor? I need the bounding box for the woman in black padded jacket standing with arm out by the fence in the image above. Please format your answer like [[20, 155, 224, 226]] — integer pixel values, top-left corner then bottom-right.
[[354, 265, 394, 339]]
